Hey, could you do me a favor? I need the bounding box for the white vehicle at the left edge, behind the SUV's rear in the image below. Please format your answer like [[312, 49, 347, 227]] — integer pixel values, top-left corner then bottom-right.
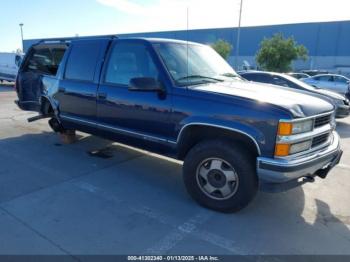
[[0, 53, 23, 82]]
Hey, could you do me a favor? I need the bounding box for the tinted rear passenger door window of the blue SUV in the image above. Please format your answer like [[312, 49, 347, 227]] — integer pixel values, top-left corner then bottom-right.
[[65, 40, 100, 82]]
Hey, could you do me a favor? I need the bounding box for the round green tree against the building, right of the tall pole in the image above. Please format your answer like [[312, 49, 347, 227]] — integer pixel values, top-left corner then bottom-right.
[[256, 33, 308, 72]]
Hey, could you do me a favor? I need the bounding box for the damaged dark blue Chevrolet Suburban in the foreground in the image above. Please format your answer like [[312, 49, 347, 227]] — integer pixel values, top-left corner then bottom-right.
[[16, 36, 342, 212]]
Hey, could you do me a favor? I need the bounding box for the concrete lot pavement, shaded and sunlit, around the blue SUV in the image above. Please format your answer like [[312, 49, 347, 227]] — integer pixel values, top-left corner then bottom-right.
[[0, 83, 350, 255]]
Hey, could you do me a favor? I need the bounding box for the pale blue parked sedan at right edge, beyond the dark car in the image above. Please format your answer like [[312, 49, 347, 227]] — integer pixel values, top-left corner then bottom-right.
[[301, 74, 350, 95]]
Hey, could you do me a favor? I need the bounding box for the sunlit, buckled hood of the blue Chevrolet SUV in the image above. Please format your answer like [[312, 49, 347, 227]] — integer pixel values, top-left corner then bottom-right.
[[191, 81, 334, 118]]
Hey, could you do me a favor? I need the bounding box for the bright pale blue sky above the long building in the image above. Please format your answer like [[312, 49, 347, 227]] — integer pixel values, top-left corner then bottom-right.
[[0, 0, 350, 52]]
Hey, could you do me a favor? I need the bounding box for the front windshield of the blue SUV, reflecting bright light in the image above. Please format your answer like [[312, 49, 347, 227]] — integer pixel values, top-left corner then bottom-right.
[[153, 43, 240, 85]]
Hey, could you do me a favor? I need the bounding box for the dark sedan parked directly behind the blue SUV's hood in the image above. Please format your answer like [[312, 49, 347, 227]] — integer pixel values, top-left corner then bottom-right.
[[239, 71, 350, 118]]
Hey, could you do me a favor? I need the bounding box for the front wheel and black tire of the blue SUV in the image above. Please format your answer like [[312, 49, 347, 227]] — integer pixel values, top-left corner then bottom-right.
[[183, 140, 258, 213]]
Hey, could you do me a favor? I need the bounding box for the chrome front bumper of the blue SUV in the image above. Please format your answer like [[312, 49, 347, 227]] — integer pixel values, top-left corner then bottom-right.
[[257, 132, 343, 184]]
